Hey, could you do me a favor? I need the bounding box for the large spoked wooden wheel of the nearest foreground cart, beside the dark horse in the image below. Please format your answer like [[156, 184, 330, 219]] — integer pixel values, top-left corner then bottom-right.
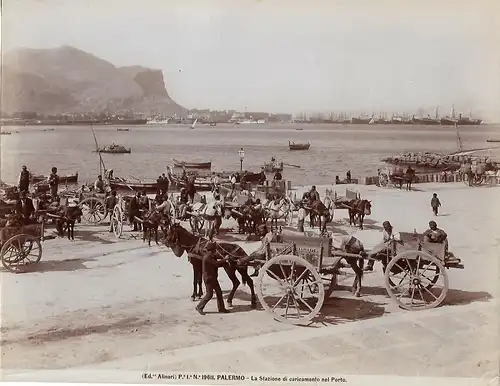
[[256, 255, 325, 324]]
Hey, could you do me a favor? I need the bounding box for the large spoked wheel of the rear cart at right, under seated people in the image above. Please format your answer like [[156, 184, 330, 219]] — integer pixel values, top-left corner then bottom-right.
[[385, 250, 448, 311]]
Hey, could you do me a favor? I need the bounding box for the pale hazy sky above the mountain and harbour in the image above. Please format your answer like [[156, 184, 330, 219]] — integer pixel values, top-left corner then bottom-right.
[[2, 0, 500, 119]]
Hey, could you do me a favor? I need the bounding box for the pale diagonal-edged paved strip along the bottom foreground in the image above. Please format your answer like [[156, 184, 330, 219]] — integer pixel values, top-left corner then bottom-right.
[[6, 300, 500, 384]]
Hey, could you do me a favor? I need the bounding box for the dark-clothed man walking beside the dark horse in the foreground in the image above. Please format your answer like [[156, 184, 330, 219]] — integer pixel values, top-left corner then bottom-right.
[[196, 241, 229, 315]]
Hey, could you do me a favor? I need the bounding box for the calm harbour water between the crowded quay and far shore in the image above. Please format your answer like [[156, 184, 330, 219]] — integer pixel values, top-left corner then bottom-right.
[[0, 124, 500, 185]]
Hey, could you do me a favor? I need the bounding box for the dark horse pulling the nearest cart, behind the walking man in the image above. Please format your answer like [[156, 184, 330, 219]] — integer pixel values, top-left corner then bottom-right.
[[165, 223, 257, 308]]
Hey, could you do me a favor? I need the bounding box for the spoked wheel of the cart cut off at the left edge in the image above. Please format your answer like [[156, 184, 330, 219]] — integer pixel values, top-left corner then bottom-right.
[[0, 234, 42, 273]]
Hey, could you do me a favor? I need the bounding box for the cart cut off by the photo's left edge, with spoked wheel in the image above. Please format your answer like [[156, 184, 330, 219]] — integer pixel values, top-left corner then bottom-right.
[[0, 224, 44, 273]]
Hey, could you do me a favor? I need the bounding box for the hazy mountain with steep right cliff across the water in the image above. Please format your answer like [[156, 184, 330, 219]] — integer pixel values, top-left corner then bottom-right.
[[2, 46, 185, 115]]
